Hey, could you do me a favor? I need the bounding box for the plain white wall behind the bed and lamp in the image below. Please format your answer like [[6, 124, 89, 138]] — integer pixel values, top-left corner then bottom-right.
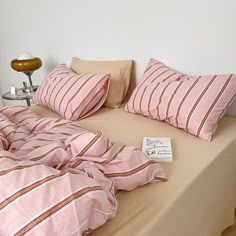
[[0, 0, 236, 110]]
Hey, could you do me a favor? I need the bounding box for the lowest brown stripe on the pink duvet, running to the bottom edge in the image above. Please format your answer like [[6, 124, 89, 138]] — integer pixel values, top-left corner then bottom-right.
[[16, 186, 102, 236]]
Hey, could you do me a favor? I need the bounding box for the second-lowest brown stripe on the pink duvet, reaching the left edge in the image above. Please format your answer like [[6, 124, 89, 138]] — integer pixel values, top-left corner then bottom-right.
[[0, 170, 78, 210]]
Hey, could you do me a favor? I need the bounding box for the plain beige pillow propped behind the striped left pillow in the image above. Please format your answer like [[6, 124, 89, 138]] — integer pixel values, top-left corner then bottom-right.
[[71, 57, 133, 108]]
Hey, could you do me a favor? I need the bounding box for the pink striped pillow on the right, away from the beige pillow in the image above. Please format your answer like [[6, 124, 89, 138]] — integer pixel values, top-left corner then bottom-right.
[[125, 59, 236, 141]]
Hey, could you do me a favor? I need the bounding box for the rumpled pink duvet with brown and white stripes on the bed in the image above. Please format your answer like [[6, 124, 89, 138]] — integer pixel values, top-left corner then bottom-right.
[[0, 106, 166, 236]]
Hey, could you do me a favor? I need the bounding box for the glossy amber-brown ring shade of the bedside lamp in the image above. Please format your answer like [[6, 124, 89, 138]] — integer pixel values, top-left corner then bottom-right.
[[11, 57, 42, 72]]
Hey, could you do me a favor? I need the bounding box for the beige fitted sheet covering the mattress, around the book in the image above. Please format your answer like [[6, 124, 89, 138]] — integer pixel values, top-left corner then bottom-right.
[[32, 105, 236, 236]]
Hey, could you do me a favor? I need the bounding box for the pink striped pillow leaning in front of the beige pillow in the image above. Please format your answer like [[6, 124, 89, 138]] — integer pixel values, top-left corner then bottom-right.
[[33, 64, 110, 120]]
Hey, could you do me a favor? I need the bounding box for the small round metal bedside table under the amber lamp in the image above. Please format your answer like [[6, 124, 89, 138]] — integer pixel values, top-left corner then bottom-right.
[[2, 86, 39, 107]]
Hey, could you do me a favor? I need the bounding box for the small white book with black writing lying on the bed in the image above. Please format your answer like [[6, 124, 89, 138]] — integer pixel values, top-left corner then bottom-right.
[[142, 137, 173, 162]]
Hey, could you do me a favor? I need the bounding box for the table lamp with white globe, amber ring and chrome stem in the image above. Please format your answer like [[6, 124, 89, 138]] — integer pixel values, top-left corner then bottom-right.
[[11, 52, 42, 91]]
